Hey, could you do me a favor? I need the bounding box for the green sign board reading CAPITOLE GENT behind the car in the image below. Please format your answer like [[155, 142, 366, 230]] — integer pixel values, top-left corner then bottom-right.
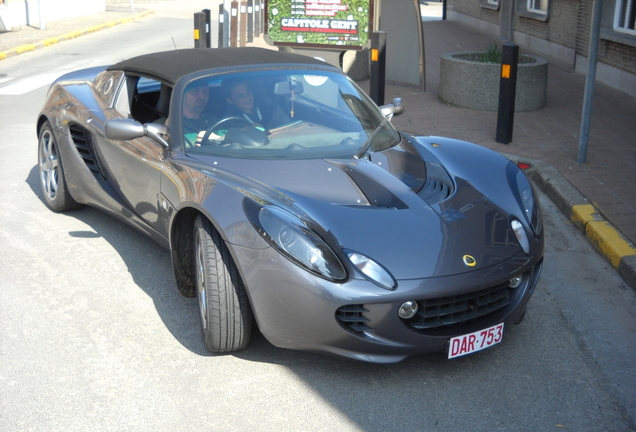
[[265, 0, 373, 49]]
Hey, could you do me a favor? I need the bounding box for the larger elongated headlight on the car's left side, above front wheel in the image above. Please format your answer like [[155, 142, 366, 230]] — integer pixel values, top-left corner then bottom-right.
[[248, 206, 347, 281]]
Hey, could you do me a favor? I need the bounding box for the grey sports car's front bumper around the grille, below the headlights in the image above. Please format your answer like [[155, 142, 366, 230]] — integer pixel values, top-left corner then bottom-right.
[[230, 245, 543, 363]]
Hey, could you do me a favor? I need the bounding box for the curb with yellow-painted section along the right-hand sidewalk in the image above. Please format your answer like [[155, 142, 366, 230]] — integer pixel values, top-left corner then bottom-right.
[[502, 153, 636, 290]]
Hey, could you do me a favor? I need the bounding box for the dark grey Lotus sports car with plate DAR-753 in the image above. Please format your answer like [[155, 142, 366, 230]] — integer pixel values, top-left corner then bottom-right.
[[37, 48, 543, 362]]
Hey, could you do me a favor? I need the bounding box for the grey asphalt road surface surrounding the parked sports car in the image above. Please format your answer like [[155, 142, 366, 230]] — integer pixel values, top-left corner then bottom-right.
[[0, 11, 636, 431]]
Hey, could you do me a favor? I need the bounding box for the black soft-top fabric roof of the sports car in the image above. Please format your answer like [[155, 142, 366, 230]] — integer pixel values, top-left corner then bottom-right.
[[108, 47, 327, 86]]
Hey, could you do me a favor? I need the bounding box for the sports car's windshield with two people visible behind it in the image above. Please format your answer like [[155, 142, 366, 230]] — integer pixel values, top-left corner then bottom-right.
[[181, 69, 400, 159]]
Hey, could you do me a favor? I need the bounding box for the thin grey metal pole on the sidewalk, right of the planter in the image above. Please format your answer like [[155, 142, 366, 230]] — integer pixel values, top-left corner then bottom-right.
[[576, 0, 603, 163]]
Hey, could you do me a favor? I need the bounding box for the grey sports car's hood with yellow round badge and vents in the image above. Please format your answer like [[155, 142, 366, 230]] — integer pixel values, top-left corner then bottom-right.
[[191, 138, 521, 279]]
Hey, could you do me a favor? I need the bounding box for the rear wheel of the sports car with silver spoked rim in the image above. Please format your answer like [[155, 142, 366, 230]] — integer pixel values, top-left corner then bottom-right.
[[38, 121, 80, 212]]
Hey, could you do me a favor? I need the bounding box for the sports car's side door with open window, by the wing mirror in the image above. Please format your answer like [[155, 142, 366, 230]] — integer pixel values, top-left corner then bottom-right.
[[97, 72, 167, 237]]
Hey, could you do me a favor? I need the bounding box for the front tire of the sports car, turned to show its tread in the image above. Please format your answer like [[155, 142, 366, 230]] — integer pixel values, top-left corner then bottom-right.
[[194, 216, 252, 353]]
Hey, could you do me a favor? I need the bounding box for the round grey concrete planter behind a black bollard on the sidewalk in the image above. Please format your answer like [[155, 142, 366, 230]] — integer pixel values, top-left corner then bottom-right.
[[439, 53, 548, 111]]
